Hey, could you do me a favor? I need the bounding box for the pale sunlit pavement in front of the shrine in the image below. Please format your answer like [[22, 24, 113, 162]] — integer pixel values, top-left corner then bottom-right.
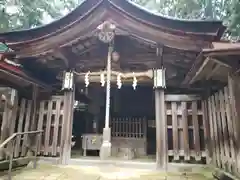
[[0, 164, 213, 180]]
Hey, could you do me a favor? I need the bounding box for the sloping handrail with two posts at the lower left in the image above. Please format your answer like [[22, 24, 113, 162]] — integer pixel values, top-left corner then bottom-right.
[[0, 130, 43, 180]]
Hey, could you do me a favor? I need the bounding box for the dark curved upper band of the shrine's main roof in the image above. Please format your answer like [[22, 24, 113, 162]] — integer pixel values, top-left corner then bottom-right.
[[0, 0, 225, 42]]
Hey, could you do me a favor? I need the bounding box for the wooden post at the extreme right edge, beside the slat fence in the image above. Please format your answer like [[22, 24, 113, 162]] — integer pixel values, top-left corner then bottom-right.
[[228, 74, 240, 173]]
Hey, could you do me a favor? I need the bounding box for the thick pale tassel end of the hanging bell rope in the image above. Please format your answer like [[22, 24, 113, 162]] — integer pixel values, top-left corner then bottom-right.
[[100, 128, 112, 160]]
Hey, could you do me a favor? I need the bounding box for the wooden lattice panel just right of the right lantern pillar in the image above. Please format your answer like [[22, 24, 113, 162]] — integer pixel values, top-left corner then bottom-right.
[[148, 100, 208, 163]]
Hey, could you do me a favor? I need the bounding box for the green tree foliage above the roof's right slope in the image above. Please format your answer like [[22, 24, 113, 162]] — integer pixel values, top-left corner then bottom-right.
[[132, 0, 240, 39]]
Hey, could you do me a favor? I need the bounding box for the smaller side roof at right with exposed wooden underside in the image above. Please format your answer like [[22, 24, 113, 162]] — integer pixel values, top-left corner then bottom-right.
[[183, 42, 240, 84]]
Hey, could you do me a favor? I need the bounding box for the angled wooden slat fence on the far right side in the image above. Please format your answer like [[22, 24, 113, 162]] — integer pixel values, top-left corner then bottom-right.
[[207, 86, 238, 174]]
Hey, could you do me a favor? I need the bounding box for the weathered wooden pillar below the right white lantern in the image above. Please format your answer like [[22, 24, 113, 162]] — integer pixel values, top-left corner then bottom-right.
[[155, 89, 168, 170]]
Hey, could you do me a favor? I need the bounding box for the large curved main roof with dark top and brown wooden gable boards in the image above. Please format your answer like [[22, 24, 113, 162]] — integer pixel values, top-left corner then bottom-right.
[[0, 0, 225, 50]]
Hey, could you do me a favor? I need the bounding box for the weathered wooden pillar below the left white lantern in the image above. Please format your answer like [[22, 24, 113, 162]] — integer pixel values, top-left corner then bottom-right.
[[60, 88, 75, 165]]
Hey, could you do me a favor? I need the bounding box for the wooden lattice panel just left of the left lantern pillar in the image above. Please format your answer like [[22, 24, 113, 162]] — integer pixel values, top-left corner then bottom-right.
[[37, 96, 64, 156]]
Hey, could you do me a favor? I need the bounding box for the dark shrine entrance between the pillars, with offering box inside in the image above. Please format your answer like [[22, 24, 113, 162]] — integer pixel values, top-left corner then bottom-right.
[[71, 85, 154, 159]]
